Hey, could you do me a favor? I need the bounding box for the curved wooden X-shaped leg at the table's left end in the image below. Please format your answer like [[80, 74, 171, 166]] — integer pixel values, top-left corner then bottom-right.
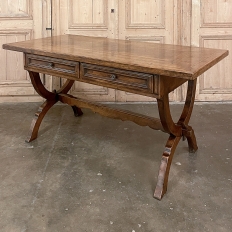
[[26, 71, 77, 142]]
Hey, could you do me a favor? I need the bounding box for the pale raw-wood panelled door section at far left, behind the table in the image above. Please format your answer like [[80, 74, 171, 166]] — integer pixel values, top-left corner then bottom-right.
[[0, 0, 51, 102]]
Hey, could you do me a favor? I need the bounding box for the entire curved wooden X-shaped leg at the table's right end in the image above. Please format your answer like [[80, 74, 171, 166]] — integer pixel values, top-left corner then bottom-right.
[[154, 80, 197, 200]]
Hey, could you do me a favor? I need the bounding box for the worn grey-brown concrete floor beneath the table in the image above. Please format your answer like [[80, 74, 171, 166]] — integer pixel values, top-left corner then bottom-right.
[[0, 103, 232, 232]]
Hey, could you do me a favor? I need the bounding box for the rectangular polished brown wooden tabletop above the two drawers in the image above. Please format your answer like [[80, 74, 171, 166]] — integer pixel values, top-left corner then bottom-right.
[[3, 35, 229, 80]]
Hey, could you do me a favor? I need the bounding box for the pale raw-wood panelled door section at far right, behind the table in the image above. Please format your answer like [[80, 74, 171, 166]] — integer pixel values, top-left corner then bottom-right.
[[191, 0, 232, 101]]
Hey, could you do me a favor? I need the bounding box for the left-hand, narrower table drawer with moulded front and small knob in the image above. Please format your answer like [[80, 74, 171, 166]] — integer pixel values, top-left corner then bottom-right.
[[25, 54, 79, 78]]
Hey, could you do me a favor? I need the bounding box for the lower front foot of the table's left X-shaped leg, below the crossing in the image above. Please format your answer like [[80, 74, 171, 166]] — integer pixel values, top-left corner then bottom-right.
[[26, 101, 57, 143]]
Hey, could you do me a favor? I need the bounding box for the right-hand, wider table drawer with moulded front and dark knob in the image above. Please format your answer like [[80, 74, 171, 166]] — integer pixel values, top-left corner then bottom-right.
[[80, 63, 154, 94]]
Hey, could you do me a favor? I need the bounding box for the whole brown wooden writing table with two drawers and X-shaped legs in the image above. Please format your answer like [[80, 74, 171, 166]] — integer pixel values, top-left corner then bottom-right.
[[3, 35, 228, 200]]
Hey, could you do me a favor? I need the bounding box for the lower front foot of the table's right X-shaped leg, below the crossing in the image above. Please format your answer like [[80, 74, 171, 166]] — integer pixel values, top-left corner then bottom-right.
[[154, 135, 181, 200]]
